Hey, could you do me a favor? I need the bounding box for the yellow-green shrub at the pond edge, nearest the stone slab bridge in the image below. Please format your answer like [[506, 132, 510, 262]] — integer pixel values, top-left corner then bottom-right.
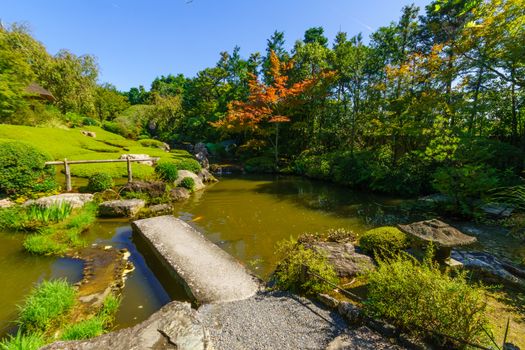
[[274, 239, 339, 294]]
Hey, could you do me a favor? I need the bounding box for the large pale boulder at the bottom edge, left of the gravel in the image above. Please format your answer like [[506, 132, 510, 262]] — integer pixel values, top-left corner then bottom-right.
[[42, 301, 213, 350]]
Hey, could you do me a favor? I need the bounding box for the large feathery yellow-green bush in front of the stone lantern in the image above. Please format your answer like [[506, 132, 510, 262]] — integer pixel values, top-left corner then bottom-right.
[[365, 252, 488, 348]]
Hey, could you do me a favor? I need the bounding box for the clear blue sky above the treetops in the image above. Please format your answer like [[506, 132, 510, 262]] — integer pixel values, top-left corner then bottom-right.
[[0, 0, 430, 90]]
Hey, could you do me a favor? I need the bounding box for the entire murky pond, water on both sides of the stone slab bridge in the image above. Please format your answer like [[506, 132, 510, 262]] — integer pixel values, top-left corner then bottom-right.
[[0, 176, 525, 335]]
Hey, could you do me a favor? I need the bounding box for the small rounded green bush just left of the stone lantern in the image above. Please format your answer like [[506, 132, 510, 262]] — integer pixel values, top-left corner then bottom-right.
[[359, 226, 408, 257]]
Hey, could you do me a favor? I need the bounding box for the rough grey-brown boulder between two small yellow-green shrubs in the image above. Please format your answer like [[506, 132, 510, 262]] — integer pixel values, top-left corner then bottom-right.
[[308, 242, 375, 277]]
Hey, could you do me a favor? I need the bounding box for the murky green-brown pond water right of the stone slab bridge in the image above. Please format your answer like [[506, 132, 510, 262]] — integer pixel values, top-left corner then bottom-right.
[[175, 176, 399, 279]]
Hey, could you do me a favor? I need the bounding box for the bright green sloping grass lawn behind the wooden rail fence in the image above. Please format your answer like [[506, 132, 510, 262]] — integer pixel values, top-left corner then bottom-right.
[[0, 124, 192, 179]]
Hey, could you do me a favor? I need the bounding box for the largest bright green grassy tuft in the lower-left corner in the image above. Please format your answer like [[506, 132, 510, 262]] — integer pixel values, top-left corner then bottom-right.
[[18, 280, 75, 331]]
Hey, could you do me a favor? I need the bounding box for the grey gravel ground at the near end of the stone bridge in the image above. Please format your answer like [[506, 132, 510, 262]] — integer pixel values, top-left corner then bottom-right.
[[199, 292, 402, 350]]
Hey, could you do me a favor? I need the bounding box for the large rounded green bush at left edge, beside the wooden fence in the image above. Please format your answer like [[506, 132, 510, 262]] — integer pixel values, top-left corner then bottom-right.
[[0, 141, 58, 196]]
